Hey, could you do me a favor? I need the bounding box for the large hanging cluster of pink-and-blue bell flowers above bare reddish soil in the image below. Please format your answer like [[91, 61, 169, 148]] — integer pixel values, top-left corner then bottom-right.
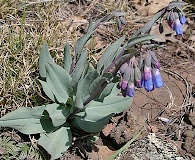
[[119, 50, 163, 97]]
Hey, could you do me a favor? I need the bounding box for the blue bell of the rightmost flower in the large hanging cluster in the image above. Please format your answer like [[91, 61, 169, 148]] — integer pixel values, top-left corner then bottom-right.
[[152, 68, 163, 88]]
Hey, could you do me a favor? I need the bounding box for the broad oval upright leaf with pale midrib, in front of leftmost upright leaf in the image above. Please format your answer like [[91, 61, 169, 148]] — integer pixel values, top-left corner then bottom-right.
[[46, 63, 72, 104]]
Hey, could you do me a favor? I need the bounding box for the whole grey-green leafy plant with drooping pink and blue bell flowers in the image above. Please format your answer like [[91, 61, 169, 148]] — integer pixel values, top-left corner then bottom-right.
[[0, 1, 186, 159]]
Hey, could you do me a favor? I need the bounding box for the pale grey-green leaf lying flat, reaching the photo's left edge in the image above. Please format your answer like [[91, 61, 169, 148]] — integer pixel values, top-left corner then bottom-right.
[[0, 106, 45, 134]]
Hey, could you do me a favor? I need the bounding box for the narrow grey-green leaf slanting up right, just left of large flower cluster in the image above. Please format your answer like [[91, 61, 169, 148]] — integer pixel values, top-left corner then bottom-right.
[[97, 36, 125, 73]]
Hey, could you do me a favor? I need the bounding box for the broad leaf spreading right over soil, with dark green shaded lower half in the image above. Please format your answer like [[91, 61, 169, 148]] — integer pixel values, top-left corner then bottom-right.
[[74, 87, 132, 132]]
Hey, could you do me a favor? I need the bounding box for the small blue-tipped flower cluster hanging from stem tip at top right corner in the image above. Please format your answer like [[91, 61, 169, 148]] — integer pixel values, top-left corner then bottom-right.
[[166, 9, 186, 35]]
